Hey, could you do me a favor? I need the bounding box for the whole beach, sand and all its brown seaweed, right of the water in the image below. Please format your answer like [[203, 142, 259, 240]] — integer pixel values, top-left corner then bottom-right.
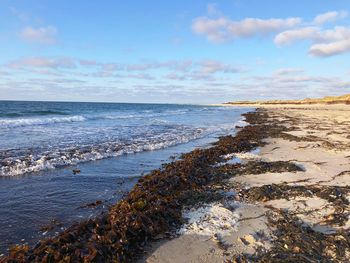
[[3, 105, 350, 262]]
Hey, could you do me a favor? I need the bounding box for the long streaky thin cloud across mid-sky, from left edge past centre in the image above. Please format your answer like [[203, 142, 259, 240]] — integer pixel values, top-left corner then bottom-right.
[[4, 56, 246, 86]]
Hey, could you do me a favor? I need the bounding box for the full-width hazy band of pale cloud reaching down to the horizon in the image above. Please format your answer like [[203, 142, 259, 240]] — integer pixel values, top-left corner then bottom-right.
[[0, 57, 350, 103]]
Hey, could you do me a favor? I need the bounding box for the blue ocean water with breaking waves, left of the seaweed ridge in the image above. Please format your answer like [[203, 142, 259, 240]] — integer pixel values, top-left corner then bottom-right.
[[0, 101, 247, 254]]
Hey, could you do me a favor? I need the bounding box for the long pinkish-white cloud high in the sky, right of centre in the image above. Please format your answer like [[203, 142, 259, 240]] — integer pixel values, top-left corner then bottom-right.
[[192, 17, 302, 42]]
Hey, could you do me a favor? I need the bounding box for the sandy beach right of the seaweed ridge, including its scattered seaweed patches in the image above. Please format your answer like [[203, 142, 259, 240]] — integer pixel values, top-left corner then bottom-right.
[[141, 105, 350, 263]]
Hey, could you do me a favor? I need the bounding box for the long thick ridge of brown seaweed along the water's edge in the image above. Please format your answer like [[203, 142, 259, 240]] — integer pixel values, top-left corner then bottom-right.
[[0, 111, 271, 262]]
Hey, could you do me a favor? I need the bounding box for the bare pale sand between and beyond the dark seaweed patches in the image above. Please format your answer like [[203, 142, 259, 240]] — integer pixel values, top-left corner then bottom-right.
[[141, 105, 350, 263]]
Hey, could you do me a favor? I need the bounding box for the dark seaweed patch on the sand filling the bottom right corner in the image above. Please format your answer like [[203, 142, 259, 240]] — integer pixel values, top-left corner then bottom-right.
[[254, 211, 350, 262]]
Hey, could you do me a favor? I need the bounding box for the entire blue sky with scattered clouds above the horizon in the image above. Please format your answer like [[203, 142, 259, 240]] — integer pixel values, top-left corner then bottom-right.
[[0, 0, 350, 104]]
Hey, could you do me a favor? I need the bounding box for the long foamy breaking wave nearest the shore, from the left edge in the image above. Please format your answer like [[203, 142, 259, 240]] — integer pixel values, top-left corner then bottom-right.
[[0, 128, 205, 176]]
